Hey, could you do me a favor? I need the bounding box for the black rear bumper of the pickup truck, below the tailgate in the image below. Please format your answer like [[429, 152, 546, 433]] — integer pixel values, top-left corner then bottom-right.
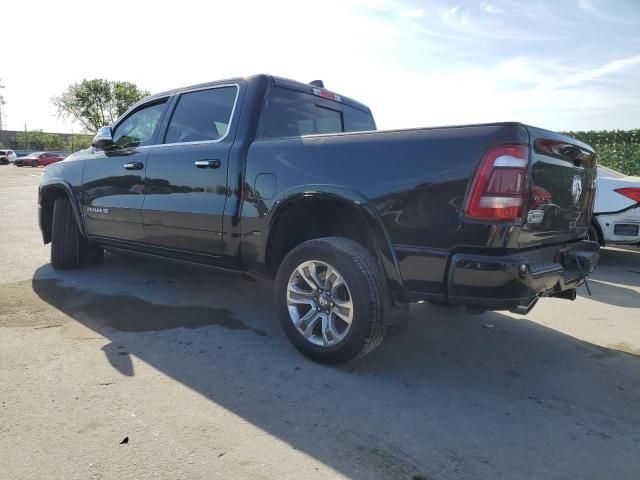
[[407, 240, 600, 313]]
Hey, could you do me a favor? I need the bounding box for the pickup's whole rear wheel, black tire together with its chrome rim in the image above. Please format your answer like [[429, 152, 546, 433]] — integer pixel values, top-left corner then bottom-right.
[[275, 237, 385, 364]]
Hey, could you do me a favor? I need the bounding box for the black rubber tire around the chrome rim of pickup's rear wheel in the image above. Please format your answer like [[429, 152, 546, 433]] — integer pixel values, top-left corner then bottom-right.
[[275, 237, 385, 364]]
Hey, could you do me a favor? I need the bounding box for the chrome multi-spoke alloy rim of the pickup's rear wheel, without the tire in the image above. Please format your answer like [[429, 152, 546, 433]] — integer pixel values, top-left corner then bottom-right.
[[287, 260, 353, 347]]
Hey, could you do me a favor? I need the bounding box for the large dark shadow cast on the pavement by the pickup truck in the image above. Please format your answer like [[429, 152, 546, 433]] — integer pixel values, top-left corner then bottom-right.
[[32, 251, 640, 479]]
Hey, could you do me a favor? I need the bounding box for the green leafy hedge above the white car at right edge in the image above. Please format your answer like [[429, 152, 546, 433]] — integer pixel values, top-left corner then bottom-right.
[[566, 129, 640, 176]]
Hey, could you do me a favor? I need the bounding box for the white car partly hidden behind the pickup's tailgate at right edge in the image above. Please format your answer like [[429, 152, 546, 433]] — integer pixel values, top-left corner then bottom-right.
[[589, 166, 640, 246]]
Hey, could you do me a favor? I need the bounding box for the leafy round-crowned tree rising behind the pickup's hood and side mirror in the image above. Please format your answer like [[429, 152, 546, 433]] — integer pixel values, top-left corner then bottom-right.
[[51, 78, 149, 133]]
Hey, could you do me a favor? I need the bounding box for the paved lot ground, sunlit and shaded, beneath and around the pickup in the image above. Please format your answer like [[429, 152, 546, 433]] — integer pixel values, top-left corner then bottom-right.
[[0, 166, 640, 480]]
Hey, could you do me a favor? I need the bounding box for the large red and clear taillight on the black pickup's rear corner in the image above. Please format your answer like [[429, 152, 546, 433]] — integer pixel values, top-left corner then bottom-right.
[[464, 145, 529, 220]]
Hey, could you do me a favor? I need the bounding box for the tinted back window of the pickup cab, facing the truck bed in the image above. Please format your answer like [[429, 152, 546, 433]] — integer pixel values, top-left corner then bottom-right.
[[264, 87, 375, 138]]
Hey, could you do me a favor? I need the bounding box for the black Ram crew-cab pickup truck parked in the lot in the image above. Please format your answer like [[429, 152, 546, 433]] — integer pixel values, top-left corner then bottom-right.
[[39, 75, 599, 363]]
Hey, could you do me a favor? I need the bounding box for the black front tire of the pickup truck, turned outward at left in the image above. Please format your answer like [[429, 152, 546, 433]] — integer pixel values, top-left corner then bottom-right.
[[51, 197, 104, 270]]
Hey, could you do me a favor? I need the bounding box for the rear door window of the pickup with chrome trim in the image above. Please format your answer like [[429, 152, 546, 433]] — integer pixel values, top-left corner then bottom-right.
[[164, 86, 238, 143]]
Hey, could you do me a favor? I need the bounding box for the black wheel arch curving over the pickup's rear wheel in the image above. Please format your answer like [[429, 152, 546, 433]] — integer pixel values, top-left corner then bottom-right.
[[260, 185, 403, 294]]
